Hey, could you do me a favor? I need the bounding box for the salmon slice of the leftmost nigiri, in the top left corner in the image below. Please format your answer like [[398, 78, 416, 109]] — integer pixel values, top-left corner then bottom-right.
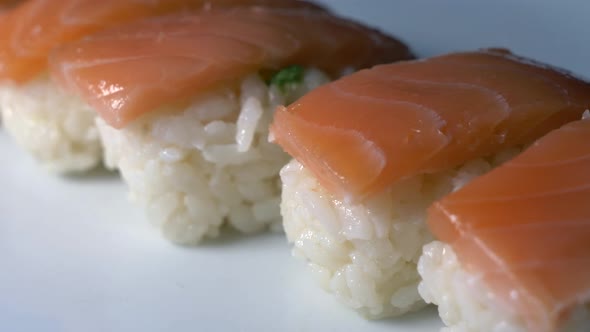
[[0, 0, 323, 83]]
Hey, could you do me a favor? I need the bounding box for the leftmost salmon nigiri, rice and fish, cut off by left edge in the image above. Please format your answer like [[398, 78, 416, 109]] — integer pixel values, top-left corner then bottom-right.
[[0, 0, 324, 173]]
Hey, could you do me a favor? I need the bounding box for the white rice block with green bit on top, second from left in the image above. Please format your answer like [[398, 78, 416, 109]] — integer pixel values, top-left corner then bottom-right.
[[97, 69, 328, 244]]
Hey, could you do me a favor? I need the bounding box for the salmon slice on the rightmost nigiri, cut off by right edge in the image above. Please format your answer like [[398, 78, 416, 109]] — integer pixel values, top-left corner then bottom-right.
[[428, 120, 590, 332]]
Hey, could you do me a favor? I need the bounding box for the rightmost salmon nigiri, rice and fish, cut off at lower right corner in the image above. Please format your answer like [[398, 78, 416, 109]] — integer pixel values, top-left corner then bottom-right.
[[418, 115, 590, 332]]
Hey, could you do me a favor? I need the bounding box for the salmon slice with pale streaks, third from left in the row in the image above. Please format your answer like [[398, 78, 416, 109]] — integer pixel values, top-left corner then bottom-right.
[[271, 49, 590, 201]]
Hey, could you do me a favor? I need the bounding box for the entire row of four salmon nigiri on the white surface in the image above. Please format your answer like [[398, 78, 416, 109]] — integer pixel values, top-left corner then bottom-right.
[[0, 0, 590, 332]]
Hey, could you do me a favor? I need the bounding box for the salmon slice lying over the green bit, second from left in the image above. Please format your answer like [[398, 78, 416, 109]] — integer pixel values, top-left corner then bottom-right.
[[50, 7, 412, 128]]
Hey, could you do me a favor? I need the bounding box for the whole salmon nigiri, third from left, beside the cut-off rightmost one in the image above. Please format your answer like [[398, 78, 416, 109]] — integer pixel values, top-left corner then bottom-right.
[[270, 49, 590, 318]]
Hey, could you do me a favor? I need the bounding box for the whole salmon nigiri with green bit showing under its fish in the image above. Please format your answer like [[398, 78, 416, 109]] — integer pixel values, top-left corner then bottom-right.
[[50, 7, 412, 244]]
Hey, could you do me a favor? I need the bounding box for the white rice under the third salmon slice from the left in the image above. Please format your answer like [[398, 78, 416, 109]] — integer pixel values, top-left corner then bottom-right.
[[281, 151, 515, 318]]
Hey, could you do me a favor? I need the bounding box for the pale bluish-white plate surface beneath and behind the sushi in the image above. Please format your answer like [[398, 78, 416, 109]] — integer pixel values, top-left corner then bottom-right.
[[0, 0, 590, 332]]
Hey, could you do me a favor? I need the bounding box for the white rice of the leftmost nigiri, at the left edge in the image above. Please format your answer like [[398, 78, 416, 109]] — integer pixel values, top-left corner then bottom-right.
[[0, 75, 102, 173]]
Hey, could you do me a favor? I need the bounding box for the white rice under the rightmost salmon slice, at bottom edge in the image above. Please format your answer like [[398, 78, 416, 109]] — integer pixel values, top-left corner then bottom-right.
[[418, 241, 590, 332]]
